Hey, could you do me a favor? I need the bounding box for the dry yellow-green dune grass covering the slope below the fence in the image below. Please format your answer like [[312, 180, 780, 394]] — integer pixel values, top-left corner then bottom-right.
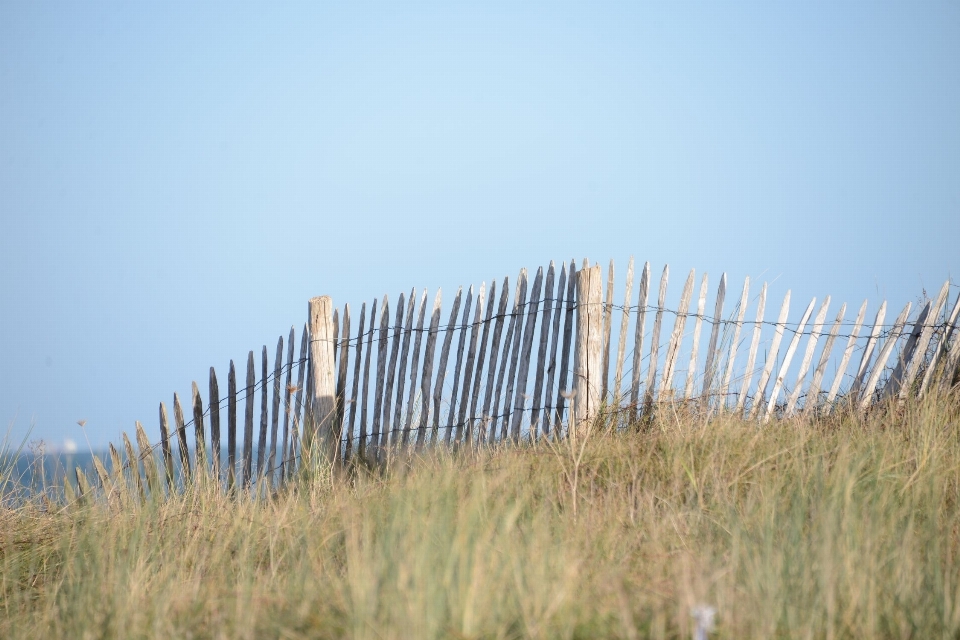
[[0, 397, 960, 638]]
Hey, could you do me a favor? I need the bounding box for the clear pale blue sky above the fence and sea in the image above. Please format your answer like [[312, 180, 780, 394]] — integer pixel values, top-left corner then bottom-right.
[[0, 2, 960, 446]]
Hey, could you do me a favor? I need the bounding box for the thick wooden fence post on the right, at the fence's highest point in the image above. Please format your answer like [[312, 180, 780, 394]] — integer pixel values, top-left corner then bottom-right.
[[573, 265, 603, 432]]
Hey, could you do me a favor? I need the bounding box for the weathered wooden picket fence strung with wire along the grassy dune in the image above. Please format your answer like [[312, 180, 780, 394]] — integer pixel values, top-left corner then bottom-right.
[[71, 260, 960, 496]]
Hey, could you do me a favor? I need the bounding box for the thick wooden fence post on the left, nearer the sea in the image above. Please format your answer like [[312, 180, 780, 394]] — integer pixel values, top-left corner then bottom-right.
[[303, 296, 340, 460]]
